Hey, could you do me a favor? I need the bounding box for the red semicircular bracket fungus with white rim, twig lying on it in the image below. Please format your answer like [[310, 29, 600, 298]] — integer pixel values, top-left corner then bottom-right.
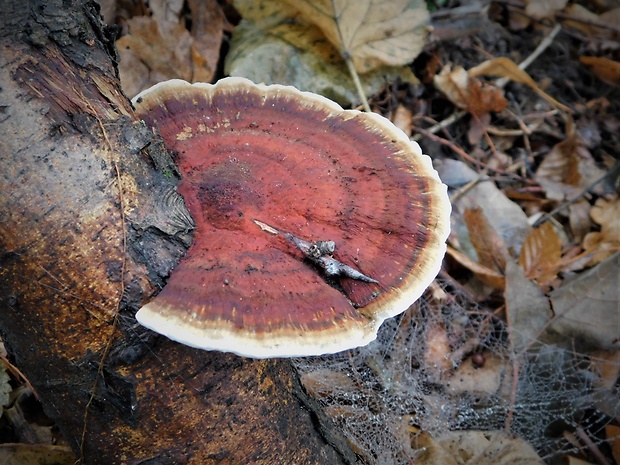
[[134, 78, 450, 358]]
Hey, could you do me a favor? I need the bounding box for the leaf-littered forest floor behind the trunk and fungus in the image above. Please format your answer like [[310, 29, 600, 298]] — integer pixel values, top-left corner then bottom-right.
[[0, 0, 620, 464]]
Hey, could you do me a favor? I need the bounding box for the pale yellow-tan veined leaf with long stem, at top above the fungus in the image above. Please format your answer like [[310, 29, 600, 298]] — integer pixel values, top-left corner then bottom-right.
[[283, 0, 429, 73]]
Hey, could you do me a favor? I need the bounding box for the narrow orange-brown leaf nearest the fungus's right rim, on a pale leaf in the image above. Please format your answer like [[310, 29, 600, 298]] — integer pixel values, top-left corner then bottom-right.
[[463, 208, 510, 274]]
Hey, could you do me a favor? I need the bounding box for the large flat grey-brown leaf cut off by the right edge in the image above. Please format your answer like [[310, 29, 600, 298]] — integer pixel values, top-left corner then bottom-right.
[[547, 253, 620, 350]]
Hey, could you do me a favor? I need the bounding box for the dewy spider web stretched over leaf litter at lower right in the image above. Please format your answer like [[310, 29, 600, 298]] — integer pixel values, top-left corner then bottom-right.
[[294, 280, 620, 465]]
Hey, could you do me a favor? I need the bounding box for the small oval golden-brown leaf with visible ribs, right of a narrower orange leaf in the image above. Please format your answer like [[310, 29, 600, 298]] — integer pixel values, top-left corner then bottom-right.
[[519, 223, 563, 286]]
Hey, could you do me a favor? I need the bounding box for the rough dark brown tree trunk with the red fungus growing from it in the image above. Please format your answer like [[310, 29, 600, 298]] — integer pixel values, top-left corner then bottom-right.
[[0, 0, 353, 465]]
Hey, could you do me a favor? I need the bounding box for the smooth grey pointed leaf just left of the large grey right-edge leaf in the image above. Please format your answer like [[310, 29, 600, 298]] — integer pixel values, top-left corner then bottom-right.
[[504, 260, 552, 351]]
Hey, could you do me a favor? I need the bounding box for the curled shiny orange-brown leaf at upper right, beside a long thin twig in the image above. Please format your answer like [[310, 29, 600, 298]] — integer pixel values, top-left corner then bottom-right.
[[433, 65, 507, 116]]
